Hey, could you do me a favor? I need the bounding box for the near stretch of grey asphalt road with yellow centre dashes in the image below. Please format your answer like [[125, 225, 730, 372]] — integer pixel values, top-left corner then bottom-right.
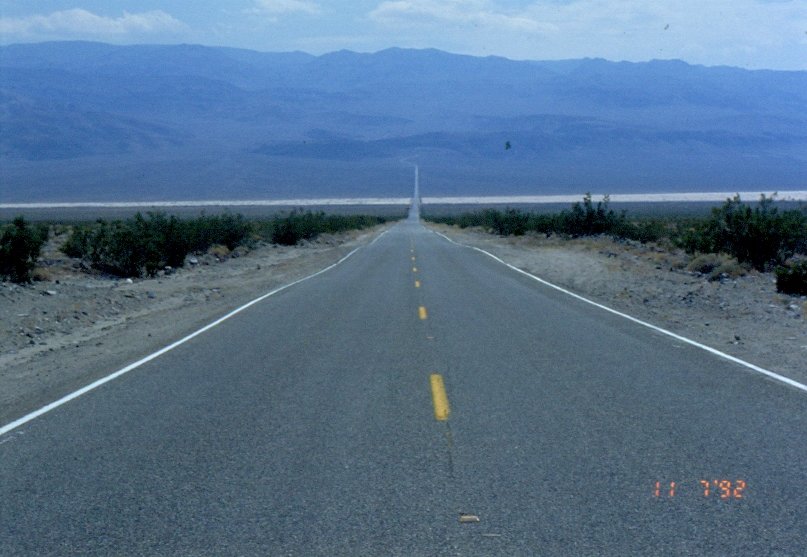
[[0, 211, 807, 556]]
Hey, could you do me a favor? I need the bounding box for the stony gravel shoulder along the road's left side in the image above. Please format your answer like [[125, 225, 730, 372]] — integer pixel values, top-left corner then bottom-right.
[[0, 224, 392, 425]]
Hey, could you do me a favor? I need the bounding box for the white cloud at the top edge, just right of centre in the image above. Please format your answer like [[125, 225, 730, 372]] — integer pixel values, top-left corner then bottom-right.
[[369, 0, 554, 33]]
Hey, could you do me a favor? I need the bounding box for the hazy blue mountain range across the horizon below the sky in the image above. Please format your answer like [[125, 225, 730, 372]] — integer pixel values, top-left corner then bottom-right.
[[0, 42, 807, 202]]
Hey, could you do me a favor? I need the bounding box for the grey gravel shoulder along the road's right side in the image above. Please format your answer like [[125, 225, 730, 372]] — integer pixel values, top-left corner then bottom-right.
[[427, 223, 807, 384]]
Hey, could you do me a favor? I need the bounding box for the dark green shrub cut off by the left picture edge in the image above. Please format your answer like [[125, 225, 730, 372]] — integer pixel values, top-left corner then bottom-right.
[[0, 217, 48, 283]]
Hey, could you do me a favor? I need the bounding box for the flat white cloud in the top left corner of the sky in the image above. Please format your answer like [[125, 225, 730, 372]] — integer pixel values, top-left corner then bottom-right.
[[0, 8, 186, 37]]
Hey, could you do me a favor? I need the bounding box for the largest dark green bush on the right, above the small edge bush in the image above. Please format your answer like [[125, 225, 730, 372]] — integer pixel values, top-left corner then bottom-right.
[[680, 195, 807, 271]]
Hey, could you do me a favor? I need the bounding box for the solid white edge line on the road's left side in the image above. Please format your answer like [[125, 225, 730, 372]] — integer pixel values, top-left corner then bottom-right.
[[0, 243, 370, 436]]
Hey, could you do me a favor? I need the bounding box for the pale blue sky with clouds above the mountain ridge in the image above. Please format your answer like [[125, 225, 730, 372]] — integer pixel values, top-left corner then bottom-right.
[[0, 0, 807, 70]]
